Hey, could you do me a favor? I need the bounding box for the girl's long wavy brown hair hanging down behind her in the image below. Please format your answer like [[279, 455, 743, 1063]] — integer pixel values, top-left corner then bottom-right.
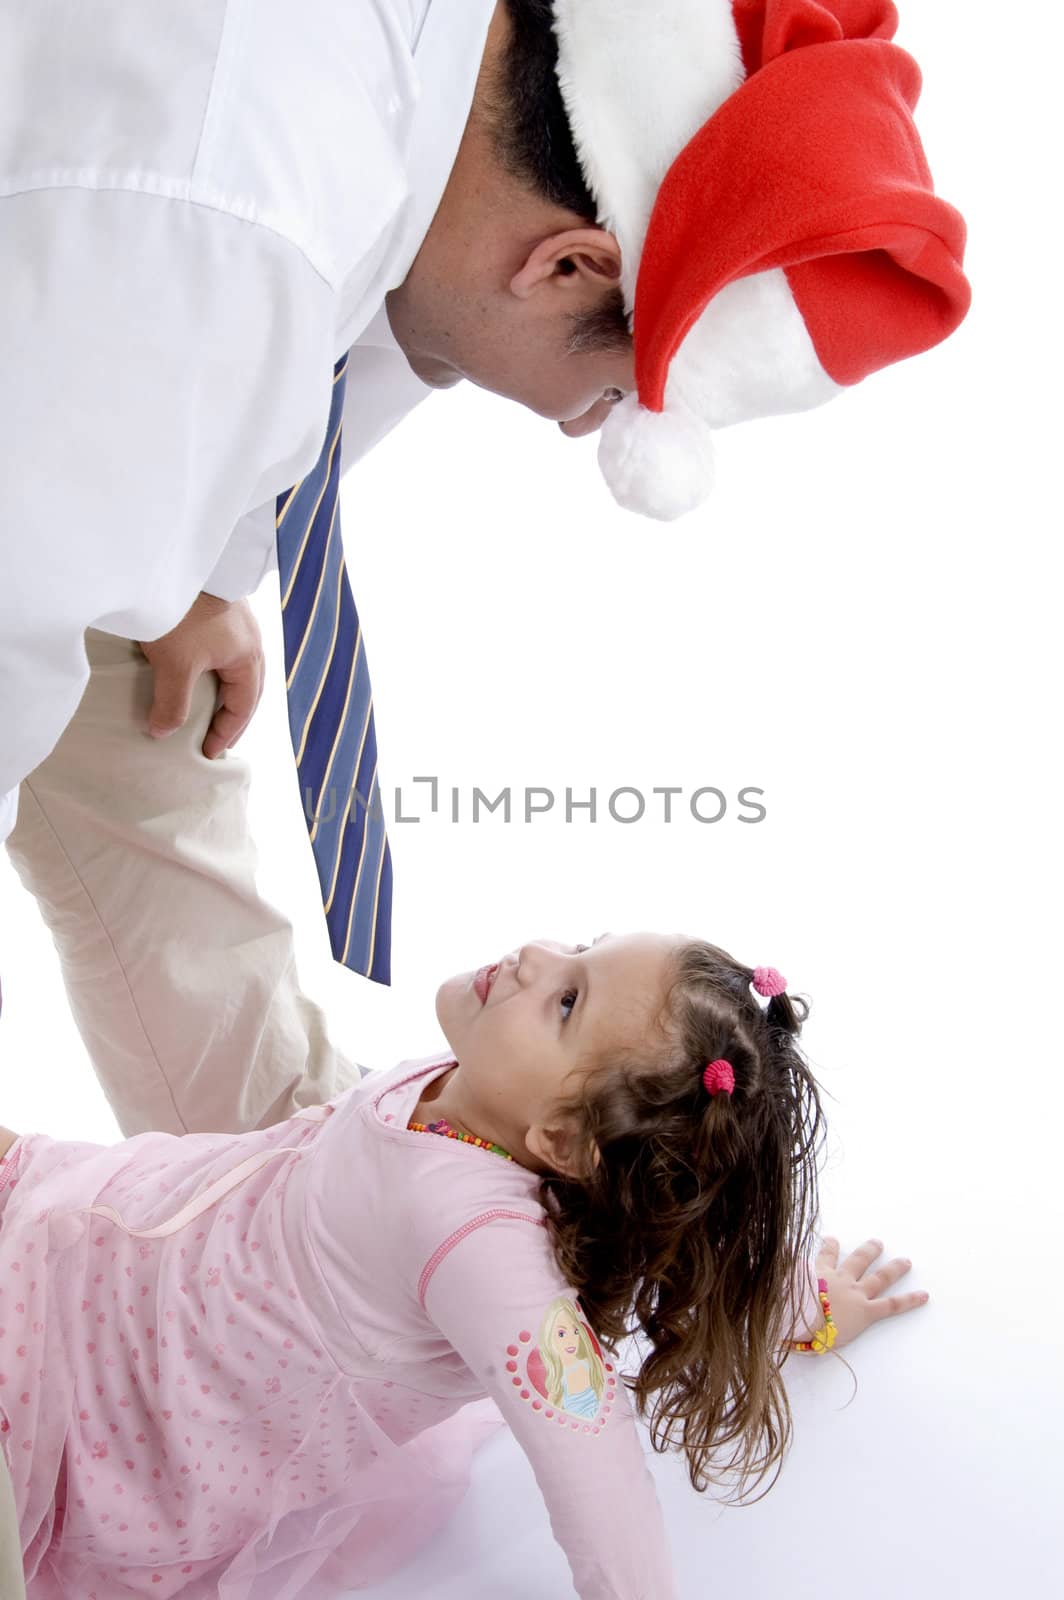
[[539, 941, 824, 1498]]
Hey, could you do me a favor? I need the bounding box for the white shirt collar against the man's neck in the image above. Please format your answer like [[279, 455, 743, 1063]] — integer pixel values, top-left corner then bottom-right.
[[389, 0, 496, 288]]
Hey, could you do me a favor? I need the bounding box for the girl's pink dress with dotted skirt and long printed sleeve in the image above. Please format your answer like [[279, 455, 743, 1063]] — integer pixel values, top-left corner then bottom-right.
[[0, 1058, 674, 1600]]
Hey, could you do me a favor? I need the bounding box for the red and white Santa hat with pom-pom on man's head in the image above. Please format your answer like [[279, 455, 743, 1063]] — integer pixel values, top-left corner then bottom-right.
[[554, 0, 970, 520]]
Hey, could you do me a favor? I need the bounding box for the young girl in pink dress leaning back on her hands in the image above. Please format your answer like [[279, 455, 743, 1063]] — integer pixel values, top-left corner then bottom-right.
[[0, 934, 926, 1600]]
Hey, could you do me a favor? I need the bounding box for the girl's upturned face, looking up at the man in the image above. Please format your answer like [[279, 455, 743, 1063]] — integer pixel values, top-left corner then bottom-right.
[[435, 933, 682, 1170]]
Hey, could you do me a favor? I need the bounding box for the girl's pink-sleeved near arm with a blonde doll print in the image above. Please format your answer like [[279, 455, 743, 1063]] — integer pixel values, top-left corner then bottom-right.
[[419, 1213, 675, 1600]]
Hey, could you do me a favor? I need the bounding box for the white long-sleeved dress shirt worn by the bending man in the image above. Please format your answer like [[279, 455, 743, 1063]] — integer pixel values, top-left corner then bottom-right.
[[0, 0, 494, 838]]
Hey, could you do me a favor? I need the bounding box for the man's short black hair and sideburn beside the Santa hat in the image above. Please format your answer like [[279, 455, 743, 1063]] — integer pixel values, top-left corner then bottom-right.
[[488, 0, 632, 354]]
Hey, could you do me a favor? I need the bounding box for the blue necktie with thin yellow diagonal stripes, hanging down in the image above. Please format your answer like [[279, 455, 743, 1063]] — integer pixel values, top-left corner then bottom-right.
[[277, 355, 392, 984]]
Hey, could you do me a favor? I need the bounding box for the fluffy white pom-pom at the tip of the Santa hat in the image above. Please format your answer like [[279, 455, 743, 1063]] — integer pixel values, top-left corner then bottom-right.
[[598, 394, 714, 522]]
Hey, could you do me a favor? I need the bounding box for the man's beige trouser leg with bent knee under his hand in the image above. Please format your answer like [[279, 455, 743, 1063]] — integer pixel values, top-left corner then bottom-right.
[[8, 630, 358, 1134]]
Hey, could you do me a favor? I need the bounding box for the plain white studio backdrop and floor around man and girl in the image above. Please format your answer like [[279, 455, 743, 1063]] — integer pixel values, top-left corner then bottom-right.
[[0, 0, 1064, 1600]]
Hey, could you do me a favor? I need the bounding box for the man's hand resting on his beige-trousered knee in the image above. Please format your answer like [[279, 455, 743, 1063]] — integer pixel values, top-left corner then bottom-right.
[[141, 594, 264, 758]]
